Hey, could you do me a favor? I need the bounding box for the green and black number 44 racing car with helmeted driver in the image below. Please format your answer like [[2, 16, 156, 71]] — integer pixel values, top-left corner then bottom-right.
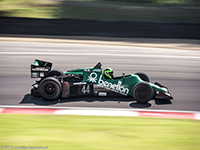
[[31, 60, 173, 103]]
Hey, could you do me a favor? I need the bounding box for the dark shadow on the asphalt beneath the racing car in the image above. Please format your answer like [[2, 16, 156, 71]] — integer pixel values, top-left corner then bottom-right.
[[19, 94, 172, 108]]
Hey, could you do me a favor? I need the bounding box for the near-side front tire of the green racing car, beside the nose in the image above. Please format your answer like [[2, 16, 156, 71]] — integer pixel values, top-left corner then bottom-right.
[[133, 82, 154, 104]]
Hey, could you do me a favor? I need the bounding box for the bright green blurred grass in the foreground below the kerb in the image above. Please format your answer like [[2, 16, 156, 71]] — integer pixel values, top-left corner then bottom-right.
[[0, 114, 200, 150]]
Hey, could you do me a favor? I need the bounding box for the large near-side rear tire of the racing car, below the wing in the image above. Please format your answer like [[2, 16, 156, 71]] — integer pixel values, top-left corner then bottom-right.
[[38, 77, 62, 100]]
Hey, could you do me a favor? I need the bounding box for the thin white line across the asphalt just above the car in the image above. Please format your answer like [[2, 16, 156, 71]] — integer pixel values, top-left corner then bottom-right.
[[0, 52, 200, 59]]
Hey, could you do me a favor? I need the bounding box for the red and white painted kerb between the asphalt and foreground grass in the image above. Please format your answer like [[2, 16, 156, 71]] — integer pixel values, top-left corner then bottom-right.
[[0, 105, 200, 120]]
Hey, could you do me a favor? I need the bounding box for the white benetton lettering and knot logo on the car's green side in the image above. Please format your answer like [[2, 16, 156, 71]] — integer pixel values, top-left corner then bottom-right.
[[87, 72, 129, 95]]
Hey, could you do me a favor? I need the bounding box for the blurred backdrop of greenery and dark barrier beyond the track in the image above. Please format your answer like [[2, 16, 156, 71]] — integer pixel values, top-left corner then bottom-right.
[[0, 0, 200, 39]]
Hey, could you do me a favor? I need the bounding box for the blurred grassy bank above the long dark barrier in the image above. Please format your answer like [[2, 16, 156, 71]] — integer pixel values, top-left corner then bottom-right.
[[0, 0, 200, 23]]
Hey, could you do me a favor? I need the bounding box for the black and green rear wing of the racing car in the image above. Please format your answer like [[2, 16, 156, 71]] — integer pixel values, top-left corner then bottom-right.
[[31, 59, 52, 78]]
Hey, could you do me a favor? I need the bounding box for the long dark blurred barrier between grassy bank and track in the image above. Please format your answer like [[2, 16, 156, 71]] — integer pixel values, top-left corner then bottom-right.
[[0, 17, 200, 39]]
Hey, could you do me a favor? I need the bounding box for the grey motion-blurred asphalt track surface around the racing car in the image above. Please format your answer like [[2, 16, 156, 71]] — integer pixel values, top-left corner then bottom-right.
[[0, 38, 200, 111]]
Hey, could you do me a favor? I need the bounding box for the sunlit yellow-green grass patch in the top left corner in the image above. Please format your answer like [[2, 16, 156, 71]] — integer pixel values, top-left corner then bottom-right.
[[0, 0, 58, 18]]
